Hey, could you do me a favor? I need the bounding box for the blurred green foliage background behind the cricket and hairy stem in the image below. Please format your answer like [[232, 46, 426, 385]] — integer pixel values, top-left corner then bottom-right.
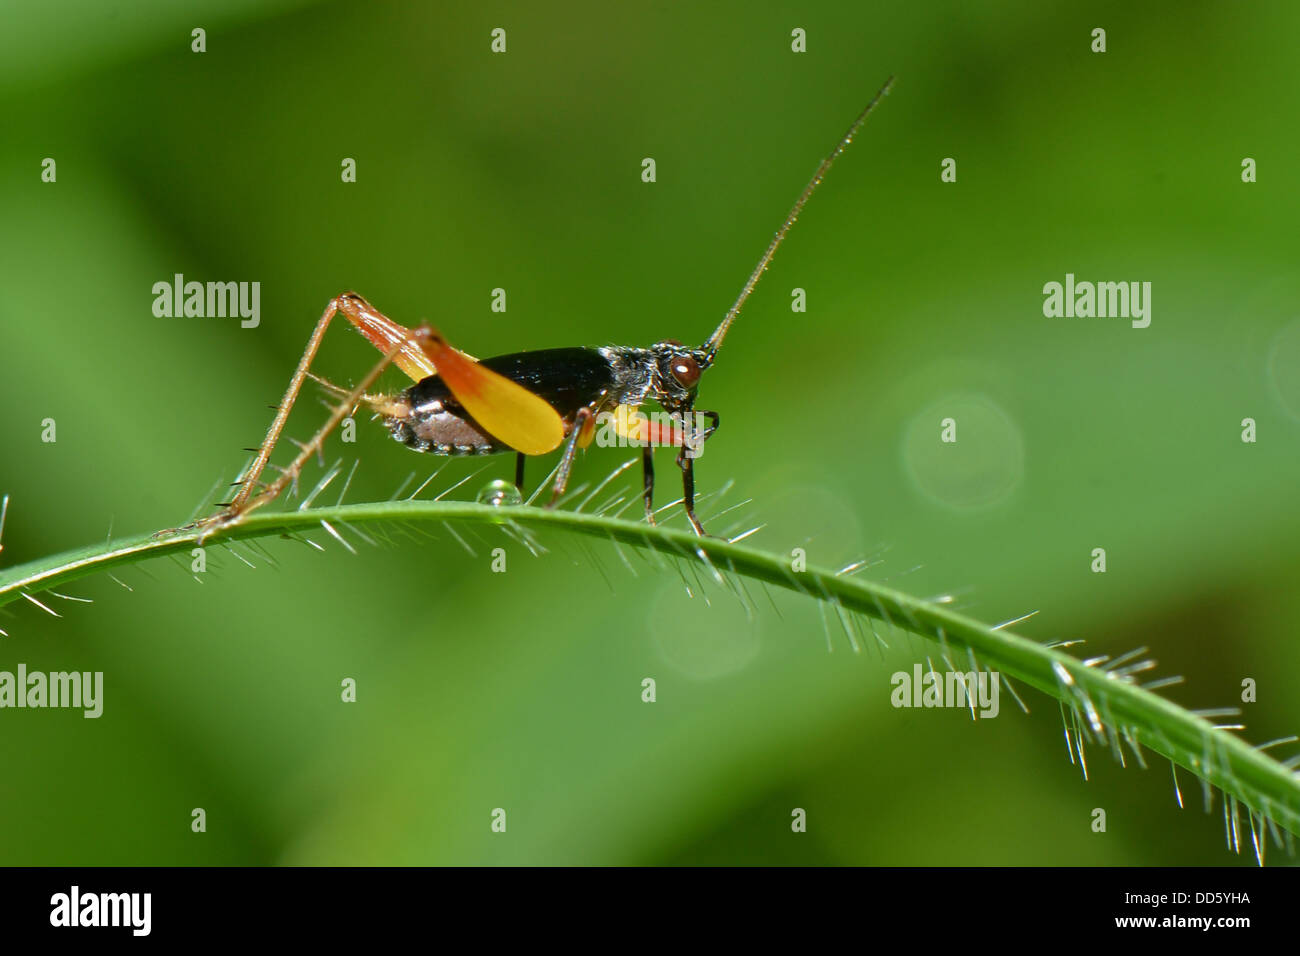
[[0, 0, 1300, 865]]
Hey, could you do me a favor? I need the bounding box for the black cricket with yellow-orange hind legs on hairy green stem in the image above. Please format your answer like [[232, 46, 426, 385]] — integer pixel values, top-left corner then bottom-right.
[[197, 77, 893, 536]]
